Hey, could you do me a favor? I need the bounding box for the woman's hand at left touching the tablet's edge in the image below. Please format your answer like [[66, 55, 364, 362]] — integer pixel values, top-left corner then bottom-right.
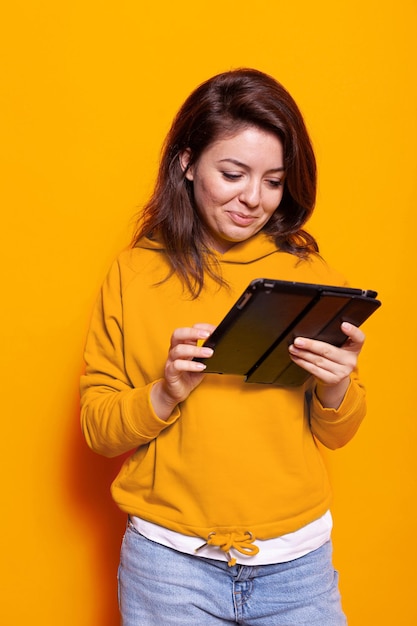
[[151, 324, 215, 420]]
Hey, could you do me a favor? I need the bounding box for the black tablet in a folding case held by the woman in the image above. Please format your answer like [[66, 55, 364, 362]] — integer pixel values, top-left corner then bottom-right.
[[196, 278, 381, 387]]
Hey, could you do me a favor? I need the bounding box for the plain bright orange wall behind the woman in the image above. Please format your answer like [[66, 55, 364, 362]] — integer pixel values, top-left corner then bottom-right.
[[0, 0, 417, 626]]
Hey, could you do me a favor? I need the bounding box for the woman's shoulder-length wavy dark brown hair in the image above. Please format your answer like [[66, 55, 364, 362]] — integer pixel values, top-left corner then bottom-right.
[[132, 68, 318, 297]]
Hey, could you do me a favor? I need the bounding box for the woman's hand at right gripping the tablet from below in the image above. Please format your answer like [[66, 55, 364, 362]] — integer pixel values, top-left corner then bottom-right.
[[289, 322, 365, 408]]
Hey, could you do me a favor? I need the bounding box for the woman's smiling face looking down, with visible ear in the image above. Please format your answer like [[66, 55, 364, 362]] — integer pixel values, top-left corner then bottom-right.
[[182, 126, 285, 253]]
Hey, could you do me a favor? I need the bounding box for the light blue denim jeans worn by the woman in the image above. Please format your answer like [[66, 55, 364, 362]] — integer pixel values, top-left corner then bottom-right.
[[119, 524, 347, 626]]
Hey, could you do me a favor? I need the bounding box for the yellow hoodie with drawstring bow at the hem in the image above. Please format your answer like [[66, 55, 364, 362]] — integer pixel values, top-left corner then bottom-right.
[[81, 233, 365, 552]]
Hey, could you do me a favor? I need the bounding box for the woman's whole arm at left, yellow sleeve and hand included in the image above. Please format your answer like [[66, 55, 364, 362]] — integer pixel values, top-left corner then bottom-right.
[[81, 263, 212, 456]]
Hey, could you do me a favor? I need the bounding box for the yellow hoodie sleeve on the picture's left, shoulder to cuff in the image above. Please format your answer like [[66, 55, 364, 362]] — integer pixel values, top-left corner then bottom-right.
[[80, 262, 180, 457]]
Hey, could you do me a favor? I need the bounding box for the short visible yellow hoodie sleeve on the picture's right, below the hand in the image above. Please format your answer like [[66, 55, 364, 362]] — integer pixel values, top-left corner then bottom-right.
[[310, 372, 366, 450]]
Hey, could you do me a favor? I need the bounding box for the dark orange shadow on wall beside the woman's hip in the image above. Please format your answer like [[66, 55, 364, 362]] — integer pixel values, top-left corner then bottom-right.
[[65, 390, 126, 626]]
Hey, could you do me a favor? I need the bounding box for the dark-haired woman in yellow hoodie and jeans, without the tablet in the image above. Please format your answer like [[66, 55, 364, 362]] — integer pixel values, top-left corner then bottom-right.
[[81, 69, 365, 626]]
